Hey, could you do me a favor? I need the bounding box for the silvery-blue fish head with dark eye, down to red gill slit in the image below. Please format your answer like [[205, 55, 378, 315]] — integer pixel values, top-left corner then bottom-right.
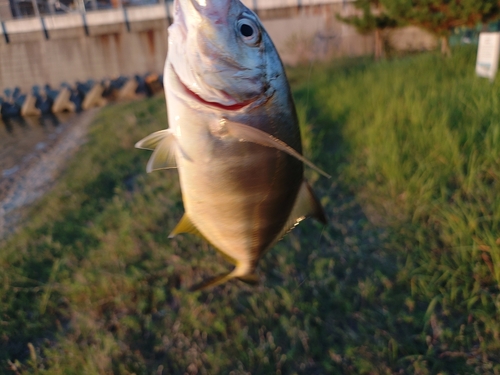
[[165, 0, 287, 110]]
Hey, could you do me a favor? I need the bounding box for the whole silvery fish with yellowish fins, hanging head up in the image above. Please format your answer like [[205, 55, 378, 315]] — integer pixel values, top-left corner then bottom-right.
[[135, 0, 330, 290]]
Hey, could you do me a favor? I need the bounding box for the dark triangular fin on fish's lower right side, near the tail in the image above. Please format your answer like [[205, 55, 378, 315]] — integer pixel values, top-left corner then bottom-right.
[[278, 180, 327, 239]]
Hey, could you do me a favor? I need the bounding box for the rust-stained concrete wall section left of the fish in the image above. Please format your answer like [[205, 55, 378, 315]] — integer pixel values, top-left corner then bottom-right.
[[0, 5, 167, 91]]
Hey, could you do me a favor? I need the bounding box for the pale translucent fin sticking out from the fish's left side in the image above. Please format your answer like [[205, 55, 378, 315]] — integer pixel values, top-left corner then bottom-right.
[[135, 129, 177, 173]]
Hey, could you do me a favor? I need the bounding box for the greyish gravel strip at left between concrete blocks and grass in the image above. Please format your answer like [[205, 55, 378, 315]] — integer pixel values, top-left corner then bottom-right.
[[0, 109, 97, 239]]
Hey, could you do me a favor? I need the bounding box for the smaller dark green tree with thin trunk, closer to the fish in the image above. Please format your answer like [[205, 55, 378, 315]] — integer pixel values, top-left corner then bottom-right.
[[337, 0, 397, 60]]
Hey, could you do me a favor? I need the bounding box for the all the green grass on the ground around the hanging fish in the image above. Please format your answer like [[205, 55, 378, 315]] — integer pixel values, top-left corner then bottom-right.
[[0, 45, 500, 375]]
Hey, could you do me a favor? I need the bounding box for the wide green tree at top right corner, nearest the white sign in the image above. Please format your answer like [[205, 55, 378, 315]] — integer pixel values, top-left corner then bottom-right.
[[380, 0, 500, 56]]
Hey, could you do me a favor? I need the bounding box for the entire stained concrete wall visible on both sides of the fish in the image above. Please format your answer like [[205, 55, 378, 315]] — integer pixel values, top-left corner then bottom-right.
[[0, 0, 433, 95]]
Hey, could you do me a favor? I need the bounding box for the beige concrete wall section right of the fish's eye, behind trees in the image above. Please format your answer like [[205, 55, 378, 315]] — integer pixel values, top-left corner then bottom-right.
[[259, 0, 436, 65]]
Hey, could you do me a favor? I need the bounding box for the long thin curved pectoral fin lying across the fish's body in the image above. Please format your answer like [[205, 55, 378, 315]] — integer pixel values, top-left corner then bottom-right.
[[224, 121, 332, 178]]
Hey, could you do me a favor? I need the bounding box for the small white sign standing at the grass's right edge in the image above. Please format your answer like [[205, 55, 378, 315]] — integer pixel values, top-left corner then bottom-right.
[[476, 32, 500, 81]]
